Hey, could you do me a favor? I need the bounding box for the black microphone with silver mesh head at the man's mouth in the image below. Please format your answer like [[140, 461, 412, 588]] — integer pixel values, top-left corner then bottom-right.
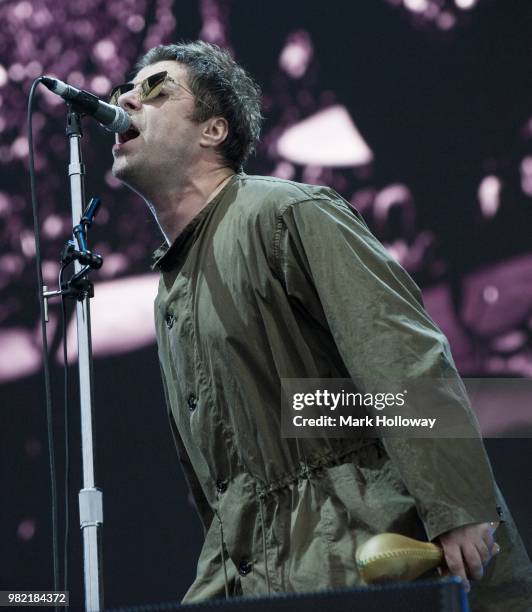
[[41, 76, 131, 134]]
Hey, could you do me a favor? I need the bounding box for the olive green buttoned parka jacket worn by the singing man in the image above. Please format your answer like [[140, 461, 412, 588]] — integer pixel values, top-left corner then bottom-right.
[[155, 174, 532, 612]]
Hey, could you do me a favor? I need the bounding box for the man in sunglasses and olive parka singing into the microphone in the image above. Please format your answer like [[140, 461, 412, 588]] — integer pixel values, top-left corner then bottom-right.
[[112, 42, 532, 612]]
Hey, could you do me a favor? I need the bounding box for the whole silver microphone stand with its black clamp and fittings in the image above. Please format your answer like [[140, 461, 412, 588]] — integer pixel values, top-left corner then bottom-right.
[[43, 104, 103, 612]]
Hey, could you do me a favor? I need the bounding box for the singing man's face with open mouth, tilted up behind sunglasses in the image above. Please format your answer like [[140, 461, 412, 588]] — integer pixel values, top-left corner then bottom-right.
[[113, 61, 202, 195]]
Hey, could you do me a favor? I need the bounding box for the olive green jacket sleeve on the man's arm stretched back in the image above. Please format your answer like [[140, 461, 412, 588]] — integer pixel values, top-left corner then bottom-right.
[[274, 192, 500, 540]]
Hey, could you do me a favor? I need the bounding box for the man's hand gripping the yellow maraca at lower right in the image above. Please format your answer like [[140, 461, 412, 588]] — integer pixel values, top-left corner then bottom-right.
[[438, 523, 500, 593]]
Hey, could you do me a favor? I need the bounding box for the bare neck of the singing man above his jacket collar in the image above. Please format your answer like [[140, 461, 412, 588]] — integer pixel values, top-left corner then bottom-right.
[[144, 167, 235, 244]]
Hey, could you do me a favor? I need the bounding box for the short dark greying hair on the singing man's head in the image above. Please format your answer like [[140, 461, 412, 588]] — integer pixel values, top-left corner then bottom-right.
[[134, 40, 262, 172]]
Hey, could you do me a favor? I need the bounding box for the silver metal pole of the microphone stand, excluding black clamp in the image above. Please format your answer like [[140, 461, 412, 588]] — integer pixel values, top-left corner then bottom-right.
[[66, 106, 103, 612]]
